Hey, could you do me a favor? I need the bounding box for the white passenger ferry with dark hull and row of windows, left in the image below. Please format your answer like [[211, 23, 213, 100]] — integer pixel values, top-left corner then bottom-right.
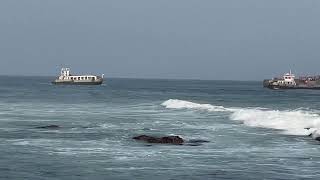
[[52, 68, 103, 85]]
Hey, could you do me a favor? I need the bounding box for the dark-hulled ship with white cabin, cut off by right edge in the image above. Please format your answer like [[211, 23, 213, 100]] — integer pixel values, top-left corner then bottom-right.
[[263, 70, 320, 90]]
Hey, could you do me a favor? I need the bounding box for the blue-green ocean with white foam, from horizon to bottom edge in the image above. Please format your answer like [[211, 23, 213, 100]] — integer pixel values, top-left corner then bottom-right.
[[0, 76, 320, 180]]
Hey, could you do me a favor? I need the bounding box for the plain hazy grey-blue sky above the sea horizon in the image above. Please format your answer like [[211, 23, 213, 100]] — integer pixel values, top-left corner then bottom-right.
[[0, 0, 320, 80]]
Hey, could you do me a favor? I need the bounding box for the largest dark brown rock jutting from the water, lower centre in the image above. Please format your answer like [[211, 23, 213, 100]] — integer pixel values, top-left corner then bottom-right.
[[133, 135, 184, 145]]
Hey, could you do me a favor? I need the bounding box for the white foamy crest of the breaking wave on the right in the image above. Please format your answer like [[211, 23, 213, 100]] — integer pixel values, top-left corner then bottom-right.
[[162, 99, 320, 135]]
